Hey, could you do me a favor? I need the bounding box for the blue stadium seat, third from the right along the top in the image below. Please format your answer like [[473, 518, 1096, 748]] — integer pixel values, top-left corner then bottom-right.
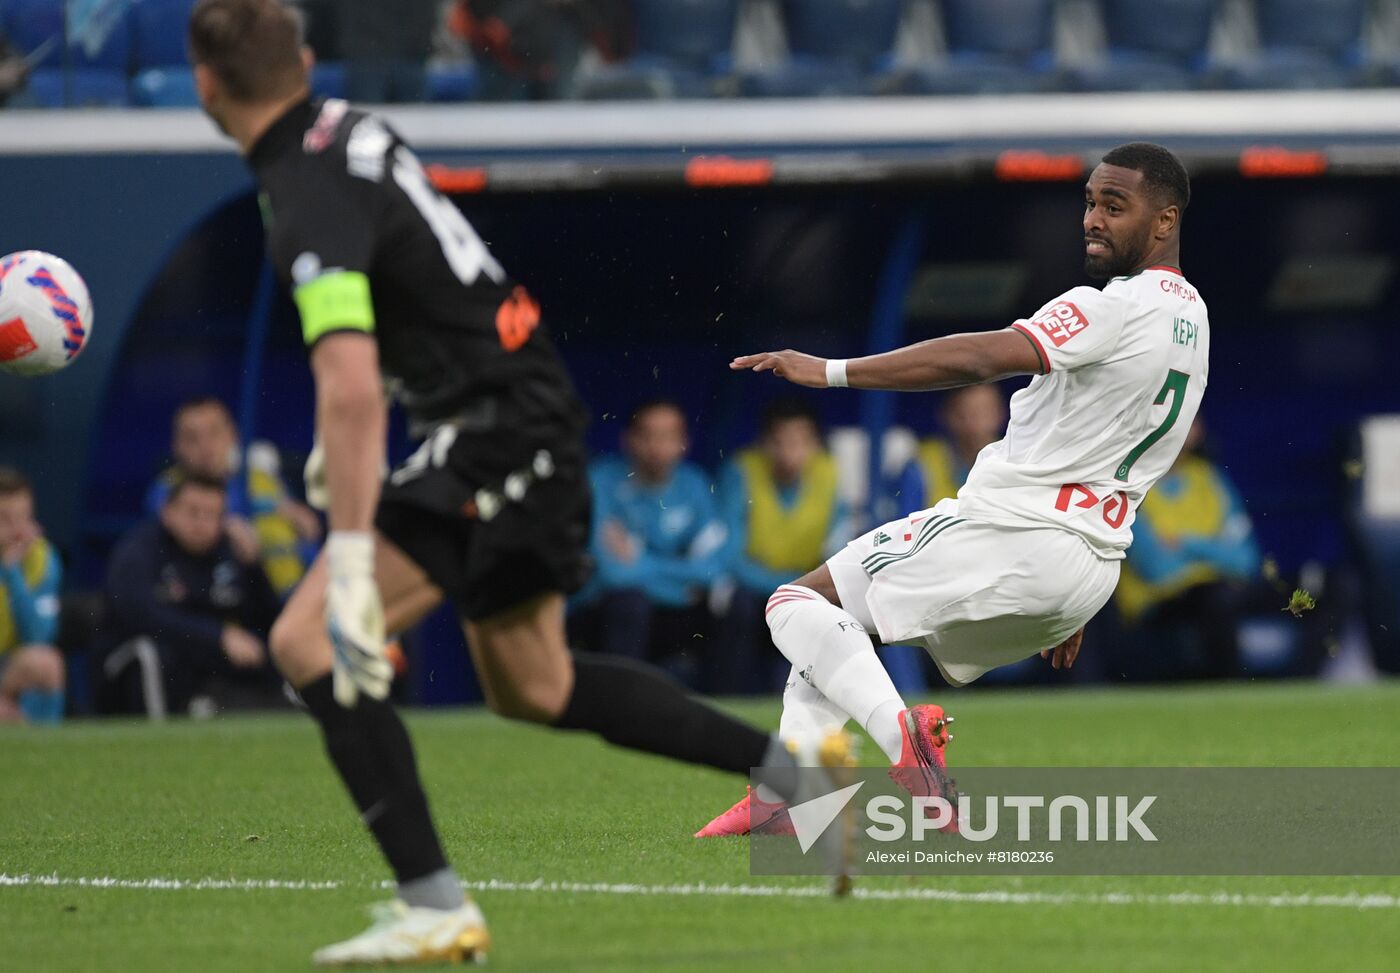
[[886, 0, 1054, 94]]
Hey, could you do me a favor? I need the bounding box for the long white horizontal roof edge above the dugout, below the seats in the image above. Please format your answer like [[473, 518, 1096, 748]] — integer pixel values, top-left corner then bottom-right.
[[0, 90, 1400, 155]]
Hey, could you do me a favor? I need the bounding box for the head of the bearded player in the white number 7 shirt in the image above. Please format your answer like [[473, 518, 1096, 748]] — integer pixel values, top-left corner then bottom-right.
[[1084, 164, 1161, 280]]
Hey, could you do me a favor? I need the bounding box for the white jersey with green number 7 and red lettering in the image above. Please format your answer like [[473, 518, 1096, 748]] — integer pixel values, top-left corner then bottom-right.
[[958, 267, 1211, 567]]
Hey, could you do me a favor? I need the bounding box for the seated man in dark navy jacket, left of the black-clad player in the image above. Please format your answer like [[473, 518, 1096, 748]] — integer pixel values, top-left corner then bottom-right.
[[102, 473, 280, 717]]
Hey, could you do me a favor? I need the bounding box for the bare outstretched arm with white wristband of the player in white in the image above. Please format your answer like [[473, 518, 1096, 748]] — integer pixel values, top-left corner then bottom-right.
[[729, 328, 1043, 392]]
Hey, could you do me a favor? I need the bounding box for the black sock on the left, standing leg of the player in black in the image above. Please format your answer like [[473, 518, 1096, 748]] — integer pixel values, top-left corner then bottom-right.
[[301, 675, 461, 890]]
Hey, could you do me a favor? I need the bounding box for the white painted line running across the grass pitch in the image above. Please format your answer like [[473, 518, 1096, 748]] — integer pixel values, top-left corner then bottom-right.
[[0, 872, 1400, 910]]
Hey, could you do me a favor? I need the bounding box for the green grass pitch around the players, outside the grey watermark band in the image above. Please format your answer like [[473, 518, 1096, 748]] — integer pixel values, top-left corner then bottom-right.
[[0, 685, 1400, 973]]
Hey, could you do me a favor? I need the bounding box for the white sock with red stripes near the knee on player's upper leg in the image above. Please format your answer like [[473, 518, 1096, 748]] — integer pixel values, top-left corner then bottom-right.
[[767, 584, 904, 763]]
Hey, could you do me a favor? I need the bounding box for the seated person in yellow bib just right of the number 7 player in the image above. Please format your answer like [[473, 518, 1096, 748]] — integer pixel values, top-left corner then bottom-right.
[[1116, 420, 1259, 678]]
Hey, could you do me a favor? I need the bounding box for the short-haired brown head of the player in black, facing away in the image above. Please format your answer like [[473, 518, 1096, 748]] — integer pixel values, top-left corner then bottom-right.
[[188, 0, 307, 104]]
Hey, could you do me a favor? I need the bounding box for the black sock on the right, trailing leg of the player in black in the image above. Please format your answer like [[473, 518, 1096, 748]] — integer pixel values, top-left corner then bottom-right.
[[554, 652, 769, 774]]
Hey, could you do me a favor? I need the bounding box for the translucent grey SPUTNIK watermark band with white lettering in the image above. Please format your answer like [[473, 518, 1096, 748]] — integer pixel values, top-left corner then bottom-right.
[[749, 767, 1400, 875]]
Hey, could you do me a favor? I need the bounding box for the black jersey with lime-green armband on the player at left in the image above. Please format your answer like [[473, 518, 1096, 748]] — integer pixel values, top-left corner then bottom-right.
[[248, 99, 585, 435]]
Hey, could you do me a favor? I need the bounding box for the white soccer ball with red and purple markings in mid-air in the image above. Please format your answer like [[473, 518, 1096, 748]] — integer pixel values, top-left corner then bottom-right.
[[0, 251, 92, 375]]
